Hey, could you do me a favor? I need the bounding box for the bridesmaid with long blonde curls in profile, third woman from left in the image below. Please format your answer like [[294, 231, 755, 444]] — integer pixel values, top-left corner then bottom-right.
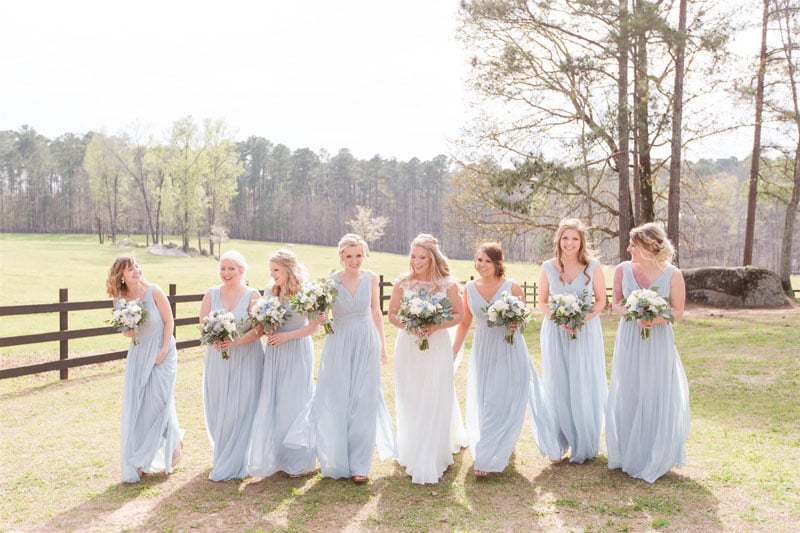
[[249, 249, 319, 477]]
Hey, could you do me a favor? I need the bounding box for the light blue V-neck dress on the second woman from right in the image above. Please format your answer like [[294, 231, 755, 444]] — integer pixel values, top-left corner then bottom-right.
[[540, 260, 608, 463]]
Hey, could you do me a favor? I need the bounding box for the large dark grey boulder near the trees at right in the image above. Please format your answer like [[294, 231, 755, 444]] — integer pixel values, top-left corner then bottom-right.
[[681, 267, 790, 307]]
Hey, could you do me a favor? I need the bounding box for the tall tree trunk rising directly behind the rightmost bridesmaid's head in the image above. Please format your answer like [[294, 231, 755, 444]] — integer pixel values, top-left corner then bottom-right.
[[667, 0, 687, 266]]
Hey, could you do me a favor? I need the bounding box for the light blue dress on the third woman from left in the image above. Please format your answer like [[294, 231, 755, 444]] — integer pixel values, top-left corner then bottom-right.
[[248, 298, 317, 477]]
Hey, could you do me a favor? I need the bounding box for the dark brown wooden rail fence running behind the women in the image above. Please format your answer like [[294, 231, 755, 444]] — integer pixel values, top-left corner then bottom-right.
[[0, 275, 800, 379]]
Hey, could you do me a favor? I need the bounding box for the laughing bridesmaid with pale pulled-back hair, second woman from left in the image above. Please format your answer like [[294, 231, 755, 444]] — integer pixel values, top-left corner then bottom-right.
[[200, 251, 264, 481]]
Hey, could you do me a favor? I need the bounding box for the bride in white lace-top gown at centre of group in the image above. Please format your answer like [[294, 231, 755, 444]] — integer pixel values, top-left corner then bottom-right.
[[389, 233, 467, 484]]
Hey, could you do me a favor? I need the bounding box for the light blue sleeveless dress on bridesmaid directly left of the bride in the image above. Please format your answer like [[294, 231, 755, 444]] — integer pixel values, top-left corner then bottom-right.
[[304, 271, 396, 478]]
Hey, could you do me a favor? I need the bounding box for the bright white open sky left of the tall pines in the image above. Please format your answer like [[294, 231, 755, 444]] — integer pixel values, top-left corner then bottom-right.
[[0, 0, 467, 160]]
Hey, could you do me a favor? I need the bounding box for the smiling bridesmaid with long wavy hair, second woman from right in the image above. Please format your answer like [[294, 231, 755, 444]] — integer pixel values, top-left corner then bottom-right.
[[539, 218, 608, 463]]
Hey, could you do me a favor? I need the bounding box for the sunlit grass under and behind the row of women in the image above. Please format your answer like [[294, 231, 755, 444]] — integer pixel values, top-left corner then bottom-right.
[[0, 236, 800, 531]]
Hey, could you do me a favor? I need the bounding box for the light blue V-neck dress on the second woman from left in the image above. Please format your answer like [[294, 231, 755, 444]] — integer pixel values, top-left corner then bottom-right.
[[203, 287, 264, 481]]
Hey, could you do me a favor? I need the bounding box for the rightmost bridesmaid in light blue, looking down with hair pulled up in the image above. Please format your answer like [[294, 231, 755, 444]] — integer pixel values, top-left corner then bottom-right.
[[606, 223, 689, 483]]
